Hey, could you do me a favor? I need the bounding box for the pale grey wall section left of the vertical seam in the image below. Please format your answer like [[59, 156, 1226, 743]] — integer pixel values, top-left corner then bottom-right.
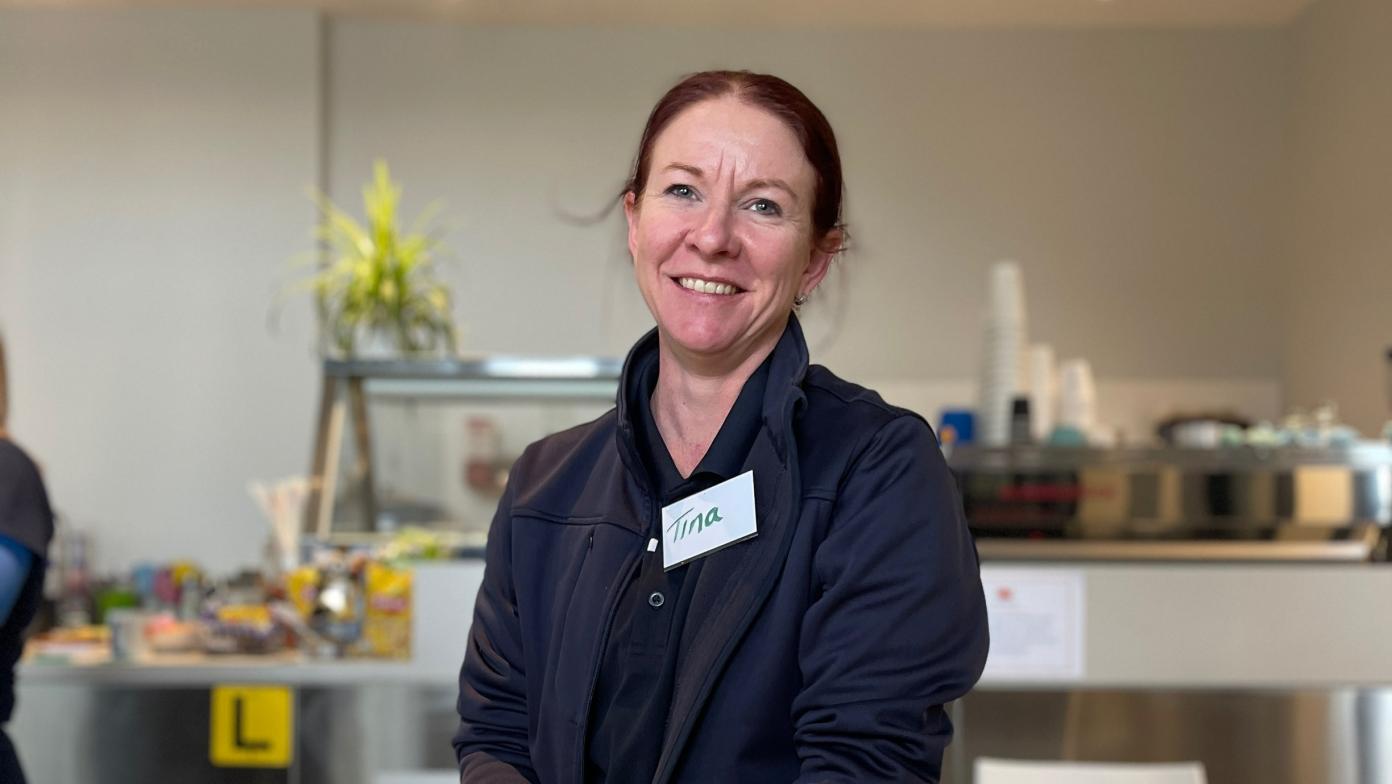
[[0, 10, 317, 571]]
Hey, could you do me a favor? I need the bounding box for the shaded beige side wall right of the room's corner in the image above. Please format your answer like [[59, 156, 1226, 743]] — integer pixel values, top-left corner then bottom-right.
[[1283, 0, 1392, 432]]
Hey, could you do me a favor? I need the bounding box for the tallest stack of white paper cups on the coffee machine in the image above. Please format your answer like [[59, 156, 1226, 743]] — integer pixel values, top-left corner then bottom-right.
[[977, 260, 1029, 447]]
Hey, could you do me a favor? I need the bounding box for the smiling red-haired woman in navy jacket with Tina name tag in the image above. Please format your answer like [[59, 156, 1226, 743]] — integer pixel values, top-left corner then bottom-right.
[[454, 71, 987, 784]]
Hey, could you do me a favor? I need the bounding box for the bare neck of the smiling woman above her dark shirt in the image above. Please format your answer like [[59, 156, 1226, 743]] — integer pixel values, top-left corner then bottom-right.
[[651, 325, 781, 478]]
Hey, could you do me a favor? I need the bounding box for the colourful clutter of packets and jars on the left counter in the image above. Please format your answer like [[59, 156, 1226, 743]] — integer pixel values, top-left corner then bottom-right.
[[25, 532, 462, 666]]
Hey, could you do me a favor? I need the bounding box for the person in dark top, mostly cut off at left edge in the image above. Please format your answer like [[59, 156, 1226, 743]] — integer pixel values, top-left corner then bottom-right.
[[0, 340, 53, 784]]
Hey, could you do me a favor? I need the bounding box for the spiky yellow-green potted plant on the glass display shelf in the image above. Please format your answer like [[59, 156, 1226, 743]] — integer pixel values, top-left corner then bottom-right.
[[292, 160, 455, 359]]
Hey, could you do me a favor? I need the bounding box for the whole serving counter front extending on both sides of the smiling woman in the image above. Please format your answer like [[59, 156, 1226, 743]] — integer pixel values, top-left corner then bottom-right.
[[10, 561, 1392, 784]]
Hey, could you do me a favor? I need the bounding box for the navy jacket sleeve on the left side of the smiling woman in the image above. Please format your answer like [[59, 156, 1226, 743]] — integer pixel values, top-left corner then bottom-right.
[[454, 486, 537, 784]]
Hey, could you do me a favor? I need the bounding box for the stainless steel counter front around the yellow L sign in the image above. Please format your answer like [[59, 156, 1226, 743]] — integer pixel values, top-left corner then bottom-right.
[[8, 670, 458, 784]]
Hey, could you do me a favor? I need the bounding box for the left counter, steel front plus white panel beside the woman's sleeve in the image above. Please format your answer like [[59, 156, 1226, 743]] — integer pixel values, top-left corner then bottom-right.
[[8, 561, 483, 784]]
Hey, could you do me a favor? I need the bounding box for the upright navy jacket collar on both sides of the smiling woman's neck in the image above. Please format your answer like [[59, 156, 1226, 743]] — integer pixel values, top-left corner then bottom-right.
[[615, 315, 807, 478]]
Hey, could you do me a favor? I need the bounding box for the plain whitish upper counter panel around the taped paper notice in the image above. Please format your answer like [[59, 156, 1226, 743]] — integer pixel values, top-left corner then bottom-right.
[[977, 561, 1392, 691]]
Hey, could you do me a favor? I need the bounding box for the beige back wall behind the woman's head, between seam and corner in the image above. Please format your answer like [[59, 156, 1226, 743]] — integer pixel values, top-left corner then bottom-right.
[[329, 19, 1290, 382]]
